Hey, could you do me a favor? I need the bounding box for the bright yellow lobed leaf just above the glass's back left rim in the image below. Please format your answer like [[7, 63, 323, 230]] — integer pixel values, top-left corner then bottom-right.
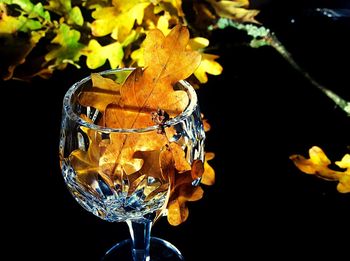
[[82, 39, 124, 69]]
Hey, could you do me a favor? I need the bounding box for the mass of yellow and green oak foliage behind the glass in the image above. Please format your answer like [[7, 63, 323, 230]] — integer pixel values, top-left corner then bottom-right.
[[0, 0, 258, 80]]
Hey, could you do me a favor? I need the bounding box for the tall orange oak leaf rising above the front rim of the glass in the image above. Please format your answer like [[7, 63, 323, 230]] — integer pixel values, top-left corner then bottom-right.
[[105, 26, 200, 128]]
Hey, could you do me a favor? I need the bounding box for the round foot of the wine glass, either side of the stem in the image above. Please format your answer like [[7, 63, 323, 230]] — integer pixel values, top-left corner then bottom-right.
[[102, 237, 185, 261]]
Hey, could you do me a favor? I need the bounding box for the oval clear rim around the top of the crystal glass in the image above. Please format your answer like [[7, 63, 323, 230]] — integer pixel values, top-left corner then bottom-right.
[[63, 67, 198, 133]]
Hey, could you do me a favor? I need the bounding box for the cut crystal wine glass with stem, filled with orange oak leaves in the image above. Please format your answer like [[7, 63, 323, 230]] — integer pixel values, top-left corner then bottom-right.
[[59, 68, 205, 261]]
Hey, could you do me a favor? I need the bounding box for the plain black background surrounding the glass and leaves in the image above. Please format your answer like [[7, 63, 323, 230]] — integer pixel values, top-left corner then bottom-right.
[[1, 1, 350, 261]]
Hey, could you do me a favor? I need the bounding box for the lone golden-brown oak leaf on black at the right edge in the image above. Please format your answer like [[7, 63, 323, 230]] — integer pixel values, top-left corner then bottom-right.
[[290, 146, 350, 193]]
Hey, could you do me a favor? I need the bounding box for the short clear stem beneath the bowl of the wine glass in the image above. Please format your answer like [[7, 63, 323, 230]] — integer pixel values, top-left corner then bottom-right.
[[126, 218, 152, 261]]
